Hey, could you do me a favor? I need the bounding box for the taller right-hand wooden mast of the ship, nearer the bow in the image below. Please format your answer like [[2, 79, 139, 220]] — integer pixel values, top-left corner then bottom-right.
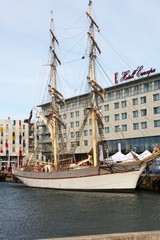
[[86, 0, 103, 167]]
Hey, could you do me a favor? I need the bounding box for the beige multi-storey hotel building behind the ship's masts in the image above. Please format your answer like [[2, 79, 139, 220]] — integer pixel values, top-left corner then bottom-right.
[[37, 69, 160, 161]]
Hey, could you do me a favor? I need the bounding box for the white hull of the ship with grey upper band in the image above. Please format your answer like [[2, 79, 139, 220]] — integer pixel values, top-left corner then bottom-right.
[[13, 164, 146, 192]]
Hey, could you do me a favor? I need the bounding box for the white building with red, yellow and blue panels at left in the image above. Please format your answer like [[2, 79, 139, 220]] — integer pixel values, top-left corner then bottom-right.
[[0, 118, 29, 167]]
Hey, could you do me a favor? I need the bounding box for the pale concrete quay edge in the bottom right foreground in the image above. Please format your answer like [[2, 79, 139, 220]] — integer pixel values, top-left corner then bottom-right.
[[43, 231, 160, 240]]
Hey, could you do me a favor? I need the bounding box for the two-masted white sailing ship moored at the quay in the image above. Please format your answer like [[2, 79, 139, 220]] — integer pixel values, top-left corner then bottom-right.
[[13, 0, 160, 192]]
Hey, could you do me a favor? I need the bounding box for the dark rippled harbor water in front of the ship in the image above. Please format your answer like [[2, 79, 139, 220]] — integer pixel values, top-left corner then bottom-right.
[[0, 182, 160, 240]]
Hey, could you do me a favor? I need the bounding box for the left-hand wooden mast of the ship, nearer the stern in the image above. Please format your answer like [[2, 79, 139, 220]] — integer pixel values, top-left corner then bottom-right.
[[49, 12, 64, 170]]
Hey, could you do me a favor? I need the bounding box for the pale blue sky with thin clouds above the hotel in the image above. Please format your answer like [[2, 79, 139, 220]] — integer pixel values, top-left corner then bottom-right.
[[0, 0, 160, 120]]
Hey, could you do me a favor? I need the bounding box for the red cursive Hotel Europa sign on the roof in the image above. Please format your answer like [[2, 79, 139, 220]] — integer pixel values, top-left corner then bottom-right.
[[114, 66, 156, 84]]
